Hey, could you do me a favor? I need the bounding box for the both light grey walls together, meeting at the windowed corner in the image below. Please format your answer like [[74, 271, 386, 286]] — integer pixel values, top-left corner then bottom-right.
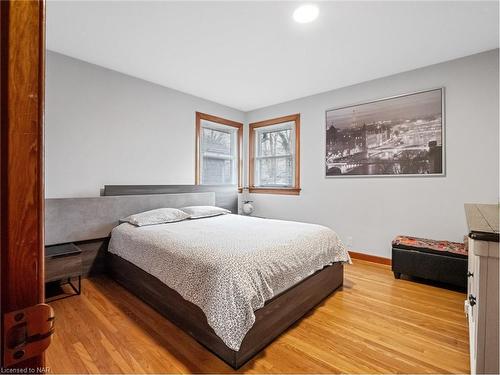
[[45, 50, 499, 257]]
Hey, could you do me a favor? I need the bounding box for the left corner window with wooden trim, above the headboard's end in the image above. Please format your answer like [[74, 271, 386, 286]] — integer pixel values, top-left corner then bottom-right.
[[195, 112, 243, 187]]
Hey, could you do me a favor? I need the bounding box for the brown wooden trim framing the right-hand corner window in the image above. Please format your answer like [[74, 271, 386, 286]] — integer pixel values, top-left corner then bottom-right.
[[248, 113, 301, 195]]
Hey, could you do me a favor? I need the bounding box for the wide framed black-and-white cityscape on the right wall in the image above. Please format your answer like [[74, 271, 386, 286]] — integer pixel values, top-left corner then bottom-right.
[[325, 88, 445, 177]]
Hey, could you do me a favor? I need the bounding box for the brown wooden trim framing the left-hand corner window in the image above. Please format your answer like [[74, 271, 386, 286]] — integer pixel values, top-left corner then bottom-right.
[[195, 112, 243, 192]]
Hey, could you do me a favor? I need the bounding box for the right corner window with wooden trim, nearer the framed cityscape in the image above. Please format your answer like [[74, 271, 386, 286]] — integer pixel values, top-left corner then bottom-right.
[[249, 114, 300, 195]]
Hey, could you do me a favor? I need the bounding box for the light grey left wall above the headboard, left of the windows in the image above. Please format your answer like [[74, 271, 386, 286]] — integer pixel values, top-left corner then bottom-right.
[[45, 51, 245, 198]]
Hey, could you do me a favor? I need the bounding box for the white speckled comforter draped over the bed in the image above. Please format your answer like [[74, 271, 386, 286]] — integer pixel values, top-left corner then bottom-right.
[[109, 215, 350, 351]]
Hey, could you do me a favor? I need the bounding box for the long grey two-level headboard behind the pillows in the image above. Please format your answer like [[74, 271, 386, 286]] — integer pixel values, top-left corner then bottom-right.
[[45, 185, 238, 245]]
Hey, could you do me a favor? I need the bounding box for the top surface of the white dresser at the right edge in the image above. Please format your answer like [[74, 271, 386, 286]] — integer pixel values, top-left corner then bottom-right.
[[465, 203, 500, 242]]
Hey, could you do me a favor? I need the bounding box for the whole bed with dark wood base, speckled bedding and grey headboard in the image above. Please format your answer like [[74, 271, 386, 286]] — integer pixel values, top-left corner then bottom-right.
[[46, 186, 350, 369]]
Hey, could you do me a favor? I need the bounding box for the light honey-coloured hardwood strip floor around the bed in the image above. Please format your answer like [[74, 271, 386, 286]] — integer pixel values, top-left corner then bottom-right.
[[47, 260, 469, 373]]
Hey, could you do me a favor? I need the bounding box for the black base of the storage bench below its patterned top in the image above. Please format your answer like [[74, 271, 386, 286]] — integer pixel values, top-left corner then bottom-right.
[[392, 247, 467, 288]]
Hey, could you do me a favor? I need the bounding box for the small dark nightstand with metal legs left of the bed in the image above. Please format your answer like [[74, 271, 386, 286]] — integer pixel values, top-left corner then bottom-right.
[[45, 243, 82, 300]]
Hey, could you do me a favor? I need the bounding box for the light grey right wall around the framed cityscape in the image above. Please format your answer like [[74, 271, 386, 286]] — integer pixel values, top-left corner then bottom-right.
[[247, 50, 499, 257]]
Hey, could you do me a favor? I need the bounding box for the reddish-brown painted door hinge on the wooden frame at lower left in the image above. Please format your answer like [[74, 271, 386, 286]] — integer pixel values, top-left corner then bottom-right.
[[3, 303, 54, 367]]
